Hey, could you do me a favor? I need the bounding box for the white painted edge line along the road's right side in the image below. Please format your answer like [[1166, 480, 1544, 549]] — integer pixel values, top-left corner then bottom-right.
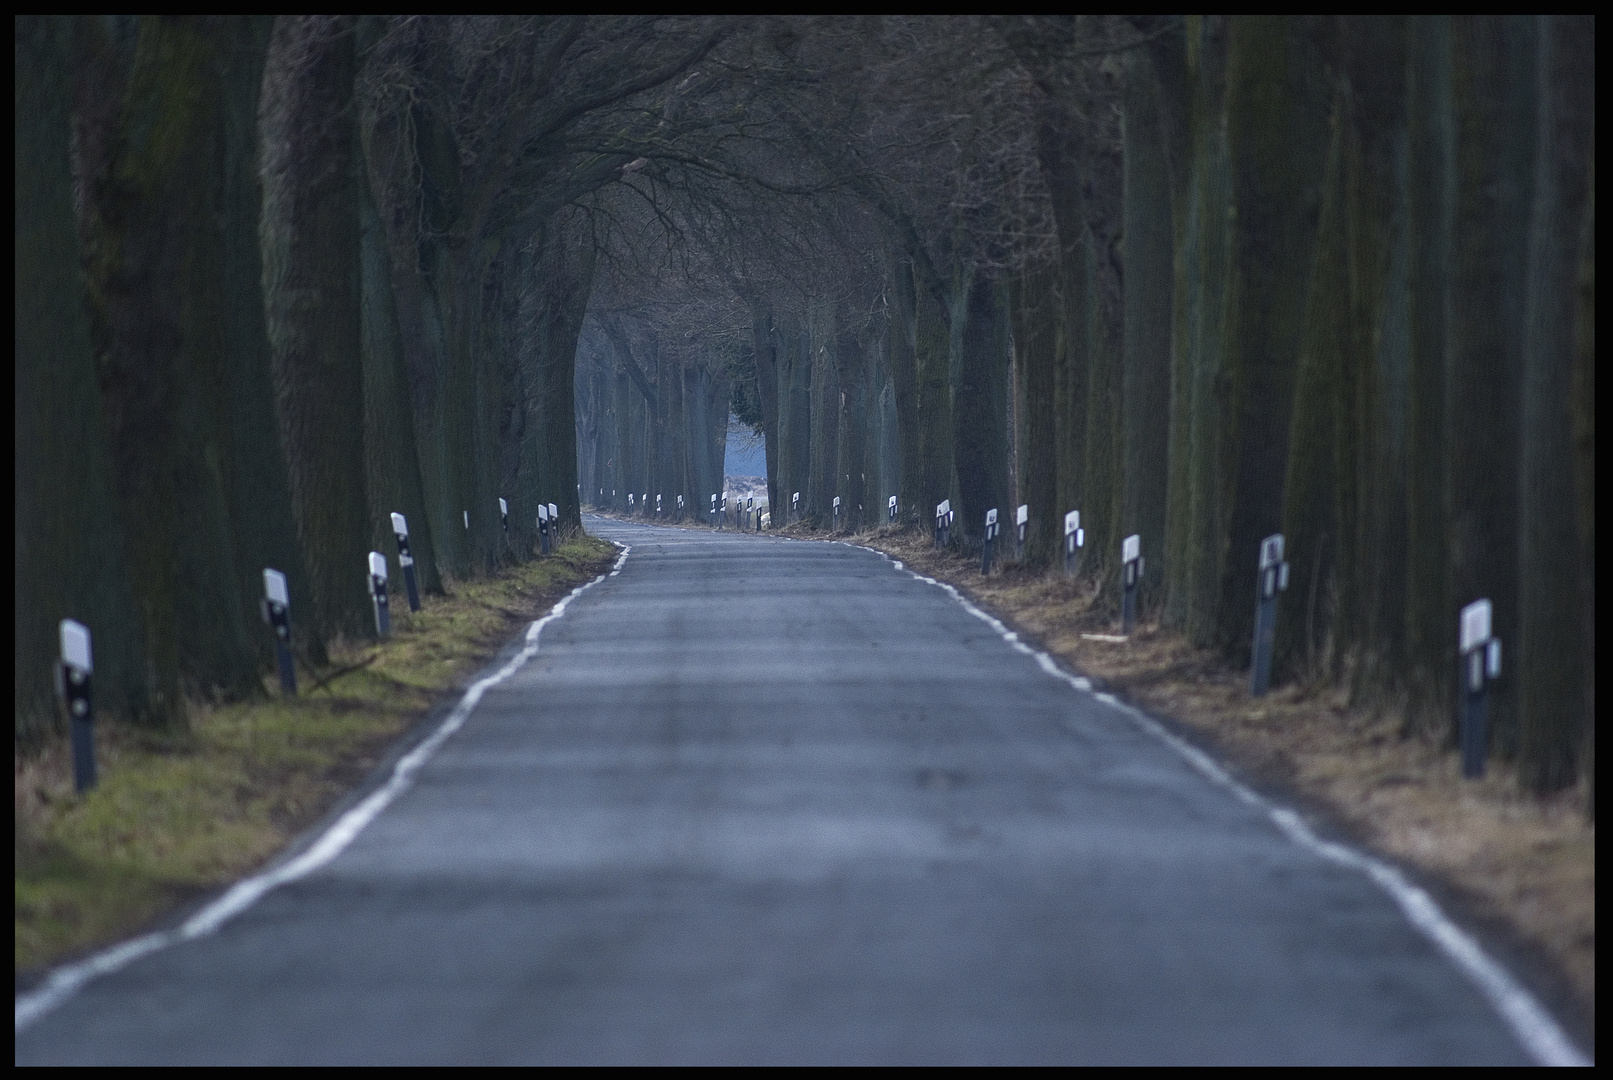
[[858, 540, 1592, 1065]]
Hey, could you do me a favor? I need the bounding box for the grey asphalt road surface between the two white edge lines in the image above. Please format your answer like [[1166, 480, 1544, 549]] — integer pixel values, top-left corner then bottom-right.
[[16, 519, 1548, 1064]]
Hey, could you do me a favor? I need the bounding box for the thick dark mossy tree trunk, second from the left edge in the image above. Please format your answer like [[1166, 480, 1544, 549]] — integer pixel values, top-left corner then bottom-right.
[[81, 18, 273, 709]]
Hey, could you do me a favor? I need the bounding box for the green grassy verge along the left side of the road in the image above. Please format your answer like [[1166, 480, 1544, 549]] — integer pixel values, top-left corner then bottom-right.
[[15, 535, 616, 985]]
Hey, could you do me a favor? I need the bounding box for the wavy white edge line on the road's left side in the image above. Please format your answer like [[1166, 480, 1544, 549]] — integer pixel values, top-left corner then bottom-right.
[[16, 542, 632, 1032]]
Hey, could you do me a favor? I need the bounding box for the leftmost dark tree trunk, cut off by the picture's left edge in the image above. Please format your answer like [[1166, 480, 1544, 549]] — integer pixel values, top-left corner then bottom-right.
[[11, 16, 151, 750]]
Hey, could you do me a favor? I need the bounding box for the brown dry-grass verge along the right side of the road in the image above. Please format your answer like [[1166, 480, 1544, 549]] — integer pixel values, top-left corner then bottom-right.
[[851, 529, 1597, 1046]]
